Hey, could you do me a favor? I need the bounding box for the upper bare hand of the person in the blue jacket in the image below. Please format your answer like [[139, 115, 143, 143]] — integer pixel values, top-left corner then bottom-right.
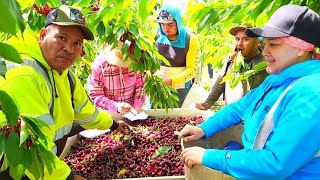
[[178, 124, 205, 142]]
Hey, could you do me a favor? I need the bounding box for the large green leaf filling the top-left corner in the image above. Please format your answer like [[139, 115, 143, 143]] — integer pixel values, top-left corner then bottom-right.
[[0, 0, 17, 35]]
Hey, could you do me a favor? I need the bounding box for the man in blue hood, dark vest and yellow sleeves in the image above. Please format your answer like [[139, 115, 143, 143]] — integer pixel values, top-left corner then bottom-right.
[[155, 3, 199, 107]]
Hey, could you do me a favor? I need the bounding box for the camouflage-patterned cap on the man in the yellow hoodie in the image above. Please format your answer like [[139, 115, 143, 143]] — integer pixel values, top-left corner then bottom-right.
[[45, 5, 94, 40]]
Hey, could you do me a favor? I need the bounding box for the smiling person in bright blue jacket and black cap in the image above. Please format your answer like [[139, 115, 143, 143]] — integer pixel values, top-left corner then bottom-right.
[[179, 5, 320, 179]]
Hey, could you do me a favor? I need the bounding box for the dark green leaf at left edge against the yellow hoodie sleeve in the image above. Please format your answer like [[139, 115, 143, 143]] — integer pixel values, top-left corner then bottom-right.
[[0, 90, 20, 126]]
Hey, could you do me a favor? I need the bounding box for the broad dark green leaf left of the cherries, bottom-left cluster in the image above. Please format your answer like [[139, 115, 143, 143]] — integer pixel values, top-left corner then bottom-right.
[[5, 131, 23, 166]]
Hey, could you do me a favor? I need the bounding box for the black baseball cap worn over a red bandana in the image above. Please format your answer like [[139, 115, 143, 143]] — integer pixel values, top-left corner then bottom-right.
[[246, 5, 320, 47]]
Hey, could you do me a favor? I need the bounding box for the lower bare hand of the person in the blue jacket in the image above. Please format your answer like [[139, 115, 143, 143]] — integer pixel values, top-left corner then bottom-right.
[[181, 147, 206, 168]]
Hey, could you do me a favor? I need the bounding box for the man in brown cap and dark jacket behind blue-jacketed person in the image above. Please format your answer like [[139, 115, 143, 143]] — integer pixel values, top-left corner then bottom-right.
[[196, 24, 268, 110]]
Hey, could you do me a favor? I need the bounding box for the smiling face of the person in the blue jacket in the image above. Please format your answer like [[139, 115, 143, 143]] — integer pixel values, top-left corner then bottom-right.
[[262, 38, 303, 74]]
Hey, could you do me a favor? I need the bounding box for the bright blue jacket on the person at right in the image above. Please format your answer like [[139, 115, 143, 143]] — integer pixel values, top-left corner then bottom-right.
[[199, 60, 320, 179]]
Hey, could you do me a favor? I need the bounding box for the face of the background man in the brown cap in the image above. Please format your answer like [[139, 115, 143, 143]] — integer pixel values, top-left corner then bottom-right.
[[235, 30, 259, 58]]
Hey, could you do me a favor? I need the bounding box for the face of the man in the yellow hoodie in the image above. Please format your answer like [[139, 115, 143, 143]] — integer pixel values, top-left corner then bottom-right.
[[39, 25, 84, 73]]
